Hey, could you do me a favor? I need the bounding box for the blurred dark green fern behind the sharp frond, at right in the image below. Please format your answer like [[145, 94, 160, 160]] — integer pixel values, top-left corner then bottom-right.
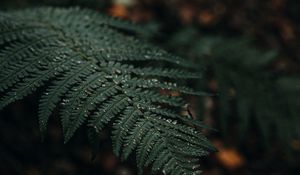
[[169, 28, 300, 149]]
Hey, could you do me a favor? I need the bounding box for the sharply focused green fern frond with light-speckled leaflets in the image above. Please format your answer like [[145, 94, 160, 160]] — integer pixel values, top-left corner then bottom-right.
[[0, 8, 214, 174]]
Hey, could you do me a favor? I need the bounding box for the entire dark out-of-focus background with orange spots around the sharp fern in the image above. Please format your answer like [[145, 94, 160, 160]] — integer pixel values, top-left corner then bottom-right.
[[0, 0, 300, 175]]
